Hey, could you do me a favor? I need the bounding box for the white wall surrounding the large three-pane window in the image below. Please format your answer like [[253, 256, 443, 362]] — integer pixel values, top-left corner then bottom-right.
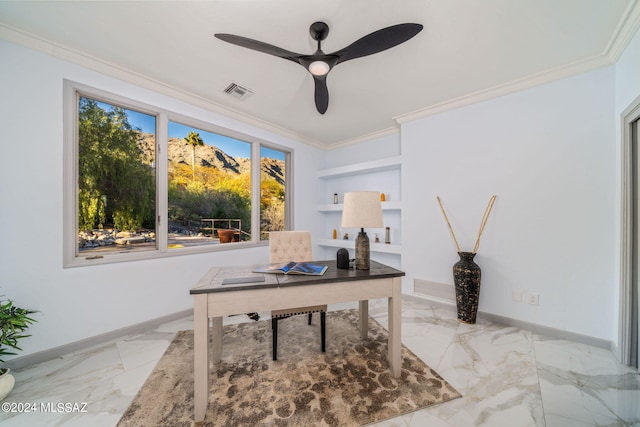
[[0, 40, 325, 362]]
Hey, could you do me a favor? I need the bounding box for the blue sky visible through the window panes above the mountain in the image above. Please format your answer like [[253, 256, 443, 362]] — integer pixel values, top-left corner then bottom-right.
[[99, 103, 284, 160]]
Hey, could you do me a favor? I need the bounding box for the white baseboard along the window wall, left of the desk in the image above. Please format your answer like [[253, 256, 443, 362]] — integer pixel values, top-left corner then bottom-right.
[[3, 309, 193, 370]]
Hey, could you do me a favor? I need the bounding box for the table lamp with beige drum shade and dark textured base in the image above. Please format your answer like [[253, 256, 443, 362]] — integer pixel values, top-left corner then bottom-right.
[[342, 191, 383, 270]]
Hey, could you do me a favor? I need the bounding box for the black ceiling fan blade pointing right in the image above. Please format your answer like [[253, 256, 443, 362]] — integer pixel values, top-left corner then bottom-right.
[[332, 24, 423, 65]]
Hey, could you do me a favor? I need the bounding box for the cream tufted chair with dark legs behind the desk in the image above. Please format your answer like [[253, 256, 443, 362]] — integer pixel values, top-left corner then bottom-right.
[[269, 231, 327, 360]]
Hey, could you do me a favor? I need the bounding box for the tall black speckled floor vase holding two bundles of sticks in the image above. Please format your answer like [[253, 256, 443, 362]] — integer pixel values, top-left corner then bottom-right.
[[436, 195, 496, 324]]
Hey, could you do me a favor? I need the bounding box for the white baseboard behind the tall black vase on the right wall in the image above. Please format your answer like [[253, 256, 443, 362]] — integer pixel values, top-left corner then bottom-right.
[[402, 294, 615, 352]]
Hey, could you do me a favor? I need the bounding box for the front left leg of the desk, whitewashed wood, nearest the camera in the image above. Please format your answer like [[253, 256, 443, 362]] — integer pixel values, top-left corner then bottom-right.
[[193, 294, 209, 422]]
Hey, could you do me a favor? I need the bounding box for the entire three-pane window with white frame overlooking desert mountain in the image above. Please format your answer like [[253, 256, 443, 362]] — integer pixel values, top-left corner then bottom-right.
[[64, 82, 291, 266]]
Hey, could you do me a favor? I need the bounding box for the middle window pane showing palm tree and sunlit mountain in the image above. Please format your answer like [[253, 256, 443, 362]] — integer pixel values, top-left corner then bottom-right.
[[167, 121, 252, 248]]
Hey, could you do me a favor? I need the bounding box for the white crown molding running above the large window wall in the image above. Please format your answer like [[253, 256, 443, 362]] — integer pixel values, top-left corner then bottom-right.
[[0, 23, 326, 150]]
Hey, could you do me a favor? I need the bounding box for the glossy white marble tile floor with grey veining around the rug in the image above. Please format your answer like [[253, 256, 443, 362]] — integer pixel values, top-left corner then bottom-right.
[[0, 298, 640, 427]]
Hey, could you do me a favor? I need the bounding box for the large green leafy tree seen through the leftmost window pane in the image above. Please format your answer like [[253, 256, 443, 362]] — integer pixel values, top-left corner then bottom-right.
[[78, 98, 155, 230]]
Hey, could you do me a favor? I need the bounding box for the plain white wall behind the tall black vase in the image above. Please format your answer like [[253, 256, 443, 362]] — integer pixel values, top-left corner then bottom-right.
[[402, 67, 618, 340]]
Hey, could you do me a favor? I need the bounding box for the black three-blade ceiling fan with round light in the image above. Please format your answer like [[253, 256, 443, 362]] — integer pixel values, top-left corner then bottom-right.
[[214, 22, 422, 114]]
